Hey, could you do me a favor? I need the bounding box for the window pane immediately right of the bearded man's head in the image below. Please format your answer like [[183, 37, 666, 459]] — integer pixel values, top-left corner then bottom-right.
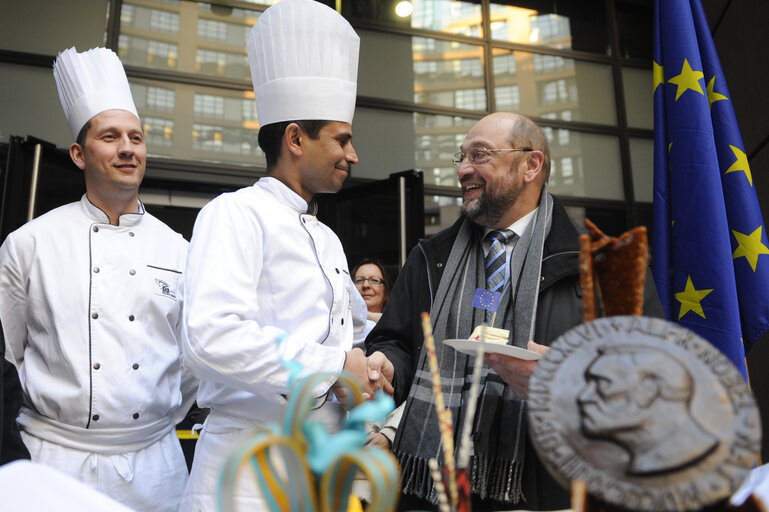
[[542, 126, 624, 199]]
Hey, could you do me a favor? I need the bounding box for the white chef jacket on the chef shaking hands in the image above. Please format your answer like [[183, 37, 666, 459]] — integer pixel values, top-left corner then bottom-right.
[[183, 177, 373, 428]]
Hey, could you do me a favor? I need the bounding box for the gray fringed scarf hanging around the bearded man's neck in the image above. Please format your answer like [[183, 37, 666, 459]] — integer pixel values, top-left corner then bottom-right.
[[393, 187, 553, 503]]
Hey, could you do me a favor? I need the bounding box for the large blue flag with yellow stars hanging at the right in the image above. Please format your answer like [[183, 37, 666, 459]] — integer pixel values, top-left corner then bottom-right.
[[653, 0, 769, 377]]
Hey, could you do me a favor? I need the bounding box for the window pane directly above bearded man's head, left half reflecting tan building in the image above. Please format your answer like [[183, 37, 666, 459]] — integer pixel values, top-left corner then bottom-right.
[[492, 48, 617, 125]]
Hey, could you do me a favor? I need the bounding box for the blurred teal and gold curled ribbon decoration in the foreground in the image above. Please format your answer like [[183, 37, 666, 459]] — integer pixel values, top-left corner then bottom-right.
[[217, 337, 400, 512]]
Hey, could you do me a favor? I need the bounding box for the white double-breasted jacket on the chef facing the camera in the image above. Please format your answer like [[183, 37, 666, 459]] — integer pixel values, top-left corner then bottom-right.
[[0, 195, 196, 454]]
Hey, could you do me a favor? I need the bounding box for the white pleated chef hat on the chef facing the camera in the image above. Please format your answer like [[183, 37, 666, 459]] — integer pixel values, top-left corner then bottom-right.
[[53, 47, 139, 139]]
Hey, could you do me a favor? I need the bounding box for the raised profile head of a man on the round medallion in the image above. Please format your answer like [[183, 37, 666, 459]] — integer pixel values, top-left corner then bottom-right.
[[577, 345, 718, 474]]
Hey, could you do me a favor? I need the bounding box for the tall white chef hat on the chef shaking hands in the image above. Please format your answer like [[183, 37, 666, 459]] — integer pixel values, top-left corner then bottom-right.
[[248, 0, 360, 126]]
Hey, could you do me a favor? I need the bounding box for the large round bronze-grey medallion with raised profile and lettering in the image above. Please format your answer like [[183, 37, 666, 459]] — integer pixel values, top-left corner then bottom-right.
[[528, 316, 761, 512]]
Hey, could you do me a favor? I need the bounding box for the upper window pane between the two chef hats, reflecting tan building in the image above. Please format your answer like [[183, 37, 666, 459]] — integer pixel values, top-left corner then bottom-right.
[[118, 0, 260, 80]]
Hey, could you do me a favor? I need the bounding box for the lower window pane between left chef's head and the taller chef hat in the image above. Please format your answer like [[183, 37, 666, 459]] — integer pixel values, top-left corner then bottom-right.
[[124, 79, 265, 166]]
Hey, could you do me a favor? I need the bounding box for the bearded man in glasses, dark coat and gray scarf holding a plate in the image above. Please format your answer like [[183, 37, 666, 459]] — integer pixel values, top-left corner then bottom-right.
[[366, 113, 659, 510]]
